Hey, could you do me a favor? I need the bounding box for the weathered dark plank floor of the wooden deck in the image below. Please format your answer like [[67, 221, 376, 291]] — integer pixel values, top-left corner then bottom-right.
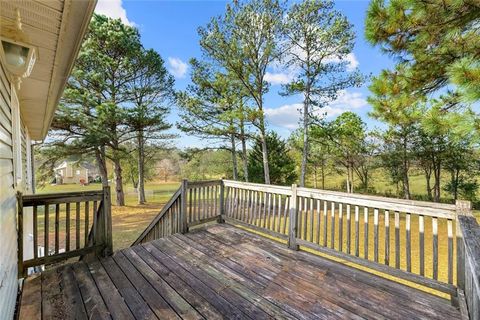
[[20, 224, 460, 320]]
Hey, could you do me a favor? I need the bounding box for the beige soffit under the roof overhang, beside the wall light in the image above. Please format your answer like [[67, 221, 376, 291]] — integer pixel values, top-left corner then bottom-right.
[[0, 0, 96, 140]]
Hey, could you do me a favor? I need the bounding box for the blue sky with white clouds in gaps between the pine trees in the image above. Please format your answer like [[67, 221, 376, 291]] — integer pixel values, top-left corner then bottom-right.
[[96, 0, 394, 147]]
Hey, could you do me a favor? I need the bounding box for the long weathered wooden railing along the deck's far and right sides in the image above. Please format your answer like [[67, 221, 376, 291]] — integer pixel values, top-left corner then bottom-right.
[[134, 180, 480, 314]]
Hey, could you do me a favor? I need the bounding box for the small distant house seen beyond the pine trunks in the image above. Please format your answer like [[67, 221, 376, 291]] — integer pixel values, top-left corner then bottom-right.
[[54, 161, 98, 184]]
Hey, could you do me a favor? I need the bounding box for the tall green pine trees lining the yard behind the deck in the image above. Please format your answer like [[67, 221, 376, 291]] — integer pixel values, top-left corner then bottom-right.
[[42, 0, 480, 205]]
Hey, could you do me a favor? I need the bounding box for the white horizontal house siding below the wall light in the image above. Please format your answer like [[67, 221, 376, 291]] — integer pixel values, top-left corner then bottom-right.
[[0, 60, 18, 319]]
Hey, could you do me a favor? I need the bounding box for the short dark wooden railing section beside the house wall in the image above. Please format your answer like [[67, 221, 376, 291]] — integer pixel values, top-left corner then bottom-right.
[[17, 187, 112, 277]]
